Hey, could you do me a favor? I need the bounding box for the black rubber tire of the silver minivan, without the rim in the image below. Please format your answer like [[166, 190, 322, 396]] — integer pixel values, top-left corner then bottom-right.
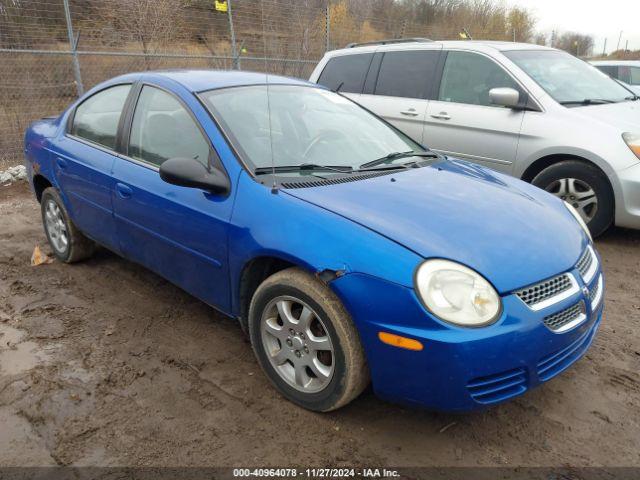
[[531, 160, 615, 237]]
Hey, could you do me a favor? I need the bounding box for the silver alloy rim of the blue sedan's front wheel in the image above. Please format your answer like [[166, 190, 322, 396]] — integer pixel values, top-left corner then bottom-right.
[[260, 296, 335, 393]]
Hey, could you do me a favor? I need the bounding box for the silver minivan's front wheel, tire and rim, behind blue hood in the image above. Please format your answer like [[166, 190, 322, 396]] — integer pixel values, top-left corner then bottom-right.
[[531, 160, 615, 237]]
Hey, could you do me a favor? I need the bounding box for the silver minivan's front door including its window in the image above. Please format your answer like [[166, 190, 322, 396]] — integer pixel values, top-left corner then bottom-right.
[[423, 51, 524, 173]]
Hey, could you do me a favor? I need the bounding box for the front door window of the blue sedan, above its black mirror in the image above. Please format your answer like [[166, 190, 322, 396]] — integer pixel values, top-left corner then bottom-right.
[[128, 86, 210, 166]]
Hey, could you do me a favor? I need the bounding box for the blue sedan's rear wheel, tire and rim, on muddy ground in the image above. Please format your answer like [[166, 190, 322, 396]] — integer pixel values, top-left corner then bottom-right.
[[40, 187, 95, 263]]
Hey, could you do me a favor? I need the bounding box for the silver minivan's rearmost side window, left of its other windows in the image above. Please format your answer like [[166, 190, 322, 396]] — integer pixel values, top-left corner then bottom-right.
[[318, 53, 373, 93]]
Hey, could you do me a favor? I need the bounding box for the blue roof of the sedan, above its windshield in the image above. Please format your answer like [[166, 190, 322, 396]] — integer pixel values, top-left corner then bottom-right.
[[137, 70, 318, 92]]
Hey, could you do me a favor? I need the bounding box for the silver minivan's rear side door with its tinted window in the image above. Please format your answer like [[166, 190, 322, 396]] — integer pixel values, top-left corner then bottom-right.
[[358, 46, 441, 143]]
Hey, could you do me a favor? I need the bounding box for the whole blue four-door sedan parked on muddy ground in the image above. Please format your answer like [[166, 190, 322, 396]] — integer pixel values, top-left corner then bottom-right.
[[25, 71, 604, 411]]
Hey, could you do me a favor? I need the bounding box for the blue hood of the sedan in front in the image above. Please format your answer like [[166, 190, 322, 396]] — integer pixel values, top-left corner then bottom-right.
[[283, 160, 587, 293]]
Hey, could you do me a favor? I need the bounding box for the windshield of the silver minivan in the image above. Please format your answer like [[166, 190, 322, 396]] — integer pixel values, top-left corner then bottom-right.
[[504, 50, 631, 104]]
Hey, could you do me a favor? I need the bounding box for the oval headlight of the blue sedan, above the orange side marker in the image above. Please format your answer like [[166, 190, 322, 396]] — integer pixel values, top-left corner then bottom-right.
[[415, 259, 502, 327]]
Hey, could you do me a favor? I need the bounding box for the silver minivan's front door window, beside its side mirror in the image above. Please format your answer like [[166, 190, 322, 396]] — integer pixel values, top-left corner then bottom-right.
[[438, 52, 520, 108]]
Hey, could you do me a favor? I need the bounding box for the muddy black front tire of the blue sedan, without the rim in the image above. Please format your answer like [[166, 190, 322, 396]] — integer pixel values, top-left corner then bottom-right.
[[249, 268, 369, 412]]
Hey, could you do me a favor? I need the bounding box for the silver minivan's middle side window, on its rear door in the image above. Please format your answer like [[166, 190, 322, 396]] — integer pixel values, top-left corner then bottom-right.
[[375, 50, 440, 98]]
